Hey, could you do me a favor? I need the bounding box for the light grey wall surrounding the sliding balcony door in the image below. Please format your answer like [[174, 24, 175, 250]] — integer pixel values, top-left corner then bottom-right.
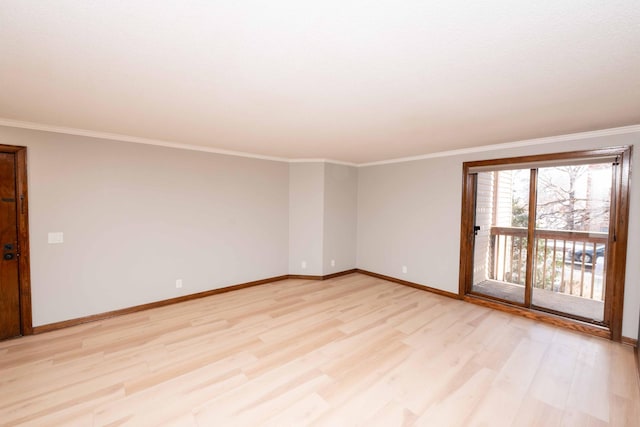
[[357, 133, 640, 338]]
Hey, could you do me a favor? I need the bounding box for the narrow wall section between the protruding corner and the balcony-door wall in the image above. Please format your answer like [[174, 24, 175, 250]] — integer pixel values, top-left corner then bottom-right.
[[323, 163, 358, 275]]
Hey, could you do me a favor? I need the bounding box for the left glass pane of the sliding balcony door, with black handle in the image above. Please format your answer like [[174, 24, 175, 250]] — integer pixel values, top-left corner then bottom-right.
[[471, 169, 530, 304]]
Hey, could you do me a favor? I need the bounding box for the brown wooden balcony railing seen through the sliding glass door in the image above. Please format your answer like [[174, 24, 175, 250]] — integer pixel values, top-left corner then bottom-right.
[[488, 227, 608, 301]]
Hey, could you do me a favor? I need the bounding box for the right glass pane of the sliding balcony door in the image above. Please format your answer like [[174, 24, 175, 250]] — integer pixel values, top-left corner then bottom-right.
[[531, 163, 613, 321]]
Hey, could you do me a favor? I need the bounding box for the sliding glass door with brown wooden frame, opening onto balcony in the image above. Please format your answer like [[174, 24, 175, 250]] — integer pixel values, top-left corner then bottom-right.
[[460, 147, 630, 335]]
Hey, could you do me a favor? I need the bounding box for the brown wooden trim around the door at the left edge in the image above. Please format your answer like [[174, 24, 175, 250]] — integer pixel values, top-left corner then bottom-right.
[[0, 144, 33, 335]]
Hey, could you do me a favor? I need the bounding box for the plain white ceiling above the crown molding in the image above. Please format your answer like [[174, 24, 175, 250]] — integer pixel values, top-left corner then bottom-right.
[[0, 0, 640, 163]]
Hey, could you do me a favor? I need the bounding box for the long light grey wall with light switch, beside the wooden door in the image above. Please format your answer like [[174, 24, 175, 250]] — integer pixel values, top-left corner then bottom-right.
[[0, 127, 289, 326]]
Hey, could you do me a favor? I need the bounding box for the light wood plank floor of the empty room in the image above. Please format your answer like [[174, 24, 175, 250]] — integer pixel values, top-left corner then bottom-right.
[[0, 274, 640, 427]]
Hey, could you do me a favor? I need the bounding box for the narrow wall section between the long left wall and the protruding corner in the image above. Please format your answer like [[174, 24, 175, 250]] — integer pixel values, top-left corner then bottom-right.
[[289, 162, 324, 276]]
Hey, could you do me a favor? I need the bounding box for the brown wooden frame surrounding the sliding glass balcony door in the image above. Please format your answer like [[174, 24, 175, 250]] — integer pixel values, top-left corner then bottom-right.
[[459, 146, 632, 341]]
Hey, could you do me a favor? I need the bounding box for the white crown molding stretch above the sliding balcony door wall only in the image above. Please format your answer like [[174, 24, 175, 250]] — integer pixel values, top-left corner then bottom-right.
[[358, 125, 640, 167]]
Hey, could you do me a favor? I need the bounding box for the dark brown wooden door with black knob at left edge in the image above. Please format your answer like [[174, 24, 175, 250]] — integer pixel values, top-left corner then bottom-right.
[[0, 153, 21, 339]]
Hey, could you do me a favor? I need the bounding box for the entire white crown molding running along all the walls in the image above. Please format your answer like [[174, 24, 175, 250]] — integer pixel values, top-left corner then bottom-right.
[[0, 117, 640, 167]]
